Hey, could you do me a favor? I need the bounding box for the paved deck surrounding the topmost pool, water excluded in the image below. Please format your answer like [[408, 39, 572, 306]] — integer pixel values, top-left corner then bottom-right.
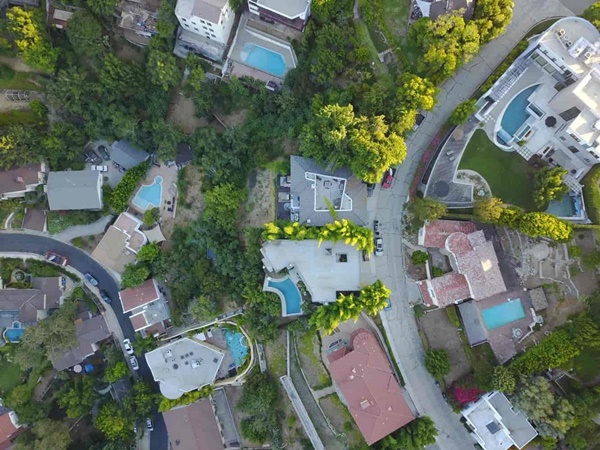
[[225, 13, 298, 82]]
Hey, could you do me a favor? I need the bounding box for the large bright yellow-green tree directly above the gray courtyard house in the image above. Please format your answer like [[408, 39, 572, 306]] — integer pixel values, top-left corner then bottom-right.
[[300, 104, 406, 183]]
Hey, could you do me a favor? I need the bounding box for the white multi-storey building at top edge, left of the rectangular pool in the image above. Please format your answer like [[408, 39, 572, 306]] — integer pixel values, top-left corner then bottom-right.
[[175, 0, 235, 44]]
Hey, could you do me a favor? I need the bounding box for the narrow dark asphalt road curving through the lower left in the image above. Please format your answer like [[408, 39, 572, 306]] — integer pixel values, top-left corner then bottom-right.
[[0, 232, 168, 450]]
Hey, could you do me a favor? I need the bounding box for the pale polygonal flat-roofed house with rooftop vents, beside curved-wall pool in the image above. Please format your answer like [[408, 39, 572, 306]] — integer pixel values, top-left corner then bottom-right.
[[145, 337, 225, 399]]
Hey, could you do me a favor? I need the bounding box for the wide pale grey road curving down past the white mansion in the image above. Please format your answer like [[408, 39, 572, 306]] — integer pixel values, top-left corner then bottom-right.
[[375, 0, 593, 450]]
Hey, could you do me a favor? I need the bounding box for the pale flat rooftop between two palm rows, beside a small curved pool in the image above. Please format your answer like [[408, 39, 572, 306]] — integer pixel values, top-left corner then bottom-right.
[[261, 240, 360, 303]]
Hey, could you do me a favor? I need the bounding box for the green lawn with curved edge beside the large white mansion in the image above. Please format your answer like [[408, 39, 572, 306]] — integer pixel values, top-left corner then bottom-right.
[[458, 130, 536, 211]]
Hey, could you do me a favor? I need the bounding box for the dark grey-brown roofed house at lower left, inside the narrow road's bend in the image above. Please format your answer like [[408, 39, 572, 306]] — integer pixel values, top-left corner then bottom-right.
[[51, 311, 112, 371]]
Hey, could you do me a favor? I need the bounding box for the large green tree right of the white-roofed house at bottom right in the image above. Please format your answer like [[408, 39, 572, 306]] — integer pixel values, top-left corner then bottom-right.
[[513, 377, 575, 439]]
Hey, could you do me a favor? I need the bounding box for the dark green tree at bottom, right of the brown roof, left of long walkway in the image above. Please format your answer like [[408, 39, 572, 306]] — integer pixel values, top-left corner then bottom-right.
[[236, 373, 278, 442]]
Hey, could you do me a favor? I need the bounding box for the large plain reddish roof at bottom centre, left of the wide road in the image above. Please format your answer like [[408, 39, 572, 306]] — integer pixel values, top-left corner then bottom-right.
[[329, 329, 414, 445]]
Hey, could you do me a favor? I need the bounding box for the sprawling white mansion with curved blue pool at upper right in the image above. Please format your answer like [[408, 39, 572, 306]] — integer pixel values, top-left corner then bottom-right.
[[476, 17, 600, 186]]
